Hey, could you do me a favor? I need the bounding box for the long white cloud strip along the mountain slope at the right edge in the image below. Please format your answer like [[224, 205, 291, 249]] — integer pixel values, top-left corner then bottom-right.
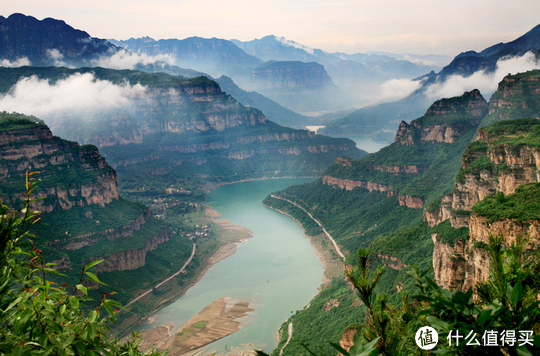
[[426, 52, 540, 99]]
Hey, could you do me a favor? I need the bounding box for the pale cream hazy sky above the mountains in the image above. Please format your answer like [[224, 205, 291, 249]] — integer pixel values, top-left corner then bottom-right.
[[1, 0, 540, 56]]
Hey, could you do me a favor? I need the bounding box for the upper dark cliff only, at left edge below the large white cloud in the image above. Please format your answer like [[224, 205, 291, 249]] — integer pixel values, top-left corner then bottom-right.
[[0, 119, 118, 212]]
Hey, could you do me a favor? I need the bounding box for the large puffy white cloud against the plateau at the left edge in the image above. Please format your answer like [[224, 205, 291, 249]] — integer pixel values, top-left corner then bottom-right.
[[0, 73, 146, 118]]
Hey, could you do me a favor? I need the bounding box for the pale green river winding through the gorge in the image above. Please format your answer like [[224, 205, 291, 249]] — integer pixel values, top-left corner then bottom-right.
[[136, 179, 324, 353]]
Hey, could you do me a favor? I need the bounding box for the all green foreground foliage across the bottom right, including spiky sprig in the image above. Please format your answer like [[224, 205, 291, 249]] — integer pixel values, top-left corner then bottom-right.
[[270, 236, 540, 356]]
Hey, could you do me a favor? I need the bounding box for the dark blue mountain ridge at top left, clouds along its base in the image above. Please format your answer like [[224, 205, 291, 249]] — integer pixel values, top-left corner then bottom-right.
[[0, 13, 204, 78]]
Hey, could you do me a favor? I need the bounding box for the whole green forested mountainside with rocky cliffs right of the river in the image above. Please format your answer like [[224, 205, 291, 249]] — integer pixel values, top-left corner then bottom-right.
[[266, 71, 540, 354]]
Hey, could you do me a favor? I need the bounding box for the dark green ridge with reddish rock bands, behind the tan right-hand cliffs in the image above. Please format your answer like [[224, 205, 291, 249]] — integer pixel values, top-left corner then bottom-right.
[[322, 90, 487, 213]]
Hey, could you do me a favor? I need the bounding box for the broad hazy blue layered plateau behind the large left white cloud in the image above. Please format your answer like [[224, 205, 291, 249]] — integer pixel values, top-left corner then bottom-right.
[[0, 68, 366, 180]]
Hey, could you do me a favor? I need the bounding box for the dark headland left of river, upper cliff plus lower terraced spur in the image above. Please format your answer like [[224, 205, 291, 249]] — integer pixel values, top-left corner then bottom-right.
[[0, 114, 169, 271]]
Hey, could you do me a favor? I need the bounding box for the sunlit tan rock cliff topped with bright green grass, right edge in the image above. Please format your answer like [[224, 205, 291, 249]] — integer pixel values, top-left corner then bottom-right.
[[424, 120, 540, 290]]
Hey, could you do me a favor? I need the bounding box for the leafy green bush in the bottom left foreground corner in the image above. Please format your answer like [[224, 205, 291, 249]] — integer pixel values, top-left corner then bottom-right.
[[0, 173, 157, 355]]
